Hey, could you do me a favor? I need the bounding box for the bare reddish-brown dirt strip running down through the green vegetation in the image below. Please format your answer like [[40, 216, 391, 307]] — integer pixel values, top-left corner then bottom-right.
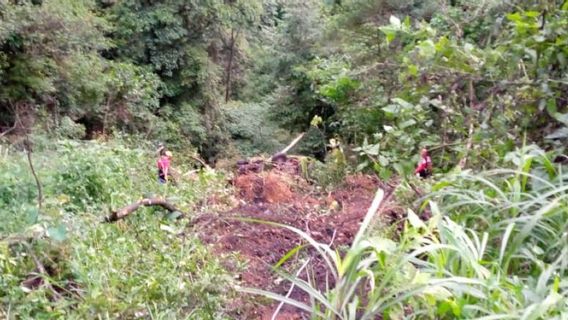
[[192, 156, 399, 319]]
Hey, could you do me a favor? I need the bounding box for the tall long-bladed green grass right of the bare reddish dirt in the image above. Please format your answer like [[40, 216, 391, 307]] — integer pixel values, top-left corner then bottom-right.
[[242, 148, 568, 320]]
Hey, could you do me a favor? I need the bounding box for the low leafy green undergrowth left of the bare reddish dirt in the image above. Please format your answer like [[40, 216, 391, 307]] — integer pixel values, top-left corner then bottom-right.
[[0, 141, 231, 319]]
